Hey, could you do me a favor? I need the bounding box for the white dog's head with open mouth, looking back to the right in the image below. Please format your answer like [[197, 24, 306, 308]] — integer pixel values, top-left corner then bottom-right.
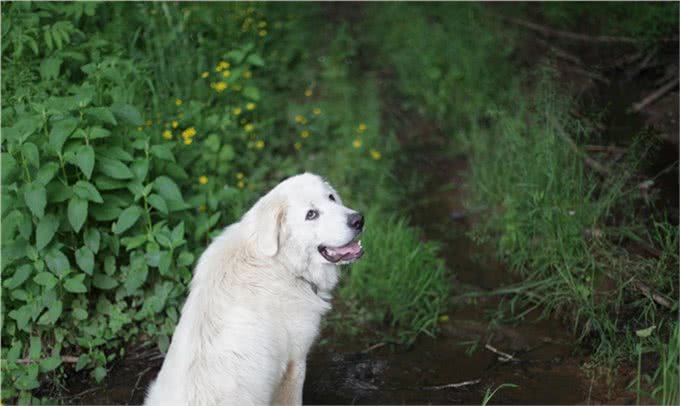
[[246, 173, 364, 264]]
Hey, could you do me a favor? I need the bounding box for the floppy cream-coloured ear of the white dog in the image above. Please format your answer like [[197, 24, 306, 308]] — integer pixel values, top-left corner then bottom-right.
[[252, 196, 285, 257]]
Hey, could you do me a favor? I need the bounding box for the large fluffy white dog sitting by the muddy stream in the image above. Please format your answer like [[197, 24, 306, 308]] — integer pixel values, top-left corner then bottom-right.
[[145, 173, 364, 406]]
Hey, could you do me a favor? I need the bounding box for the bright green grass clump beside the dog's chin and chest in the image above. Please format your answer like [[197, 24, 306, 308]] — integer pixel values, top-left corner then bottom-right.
[[340, 209, 449, 344]]
